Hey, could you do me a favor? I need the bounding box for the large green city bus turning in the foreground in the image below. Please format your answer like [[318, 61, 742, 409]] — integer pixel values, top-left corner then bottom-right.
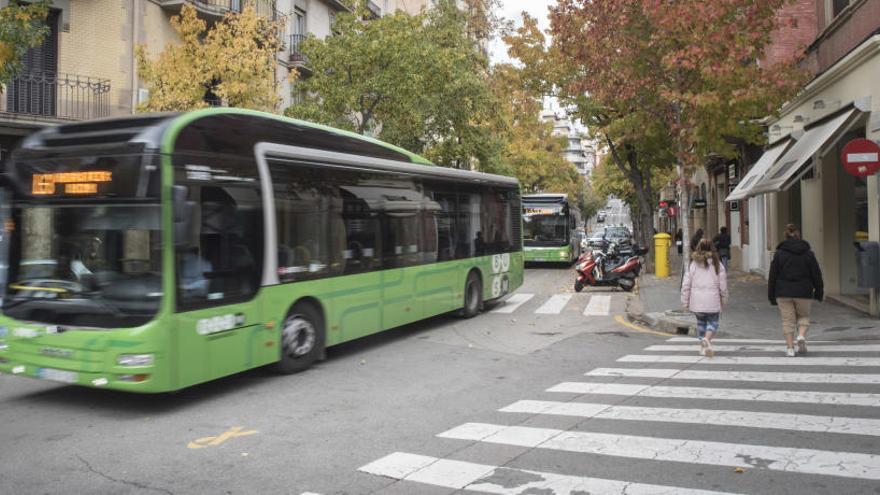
[[0, 108, 523, 392]]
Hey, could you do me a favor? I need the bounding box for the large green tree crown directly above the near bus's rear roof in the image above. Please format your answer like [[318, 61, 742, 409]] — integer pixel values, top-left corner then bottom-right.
[[285, 0, 502, 171]]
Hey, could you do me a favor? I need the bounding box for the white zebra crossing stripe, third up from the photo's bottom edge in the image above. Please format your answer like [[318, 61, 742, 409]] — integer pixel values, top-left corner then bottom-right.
[[499, 400, 880, 437]]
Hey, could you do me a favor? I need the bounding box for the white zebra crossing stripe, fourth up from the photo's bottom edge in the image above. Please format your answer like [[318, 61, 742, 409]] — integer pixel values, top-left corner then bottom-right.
[[547, 382, 880, 408]]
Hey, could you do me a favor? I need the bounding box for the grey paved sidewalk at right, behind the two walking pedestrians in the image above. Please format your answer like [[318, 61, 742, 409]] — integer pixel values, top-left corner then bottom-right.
[[627, 257, 880, 340]]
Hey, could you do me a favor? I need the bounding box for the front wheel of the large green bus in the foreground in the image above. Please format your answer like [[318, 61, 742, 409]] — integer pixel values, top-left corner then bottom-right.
[[275, 302, 325, 374]]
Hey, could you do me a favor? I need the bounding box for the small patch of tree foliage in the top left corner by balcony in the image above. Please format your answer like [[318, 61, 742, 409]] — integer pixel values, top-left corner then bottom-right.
[[0, 0, 49, 85]]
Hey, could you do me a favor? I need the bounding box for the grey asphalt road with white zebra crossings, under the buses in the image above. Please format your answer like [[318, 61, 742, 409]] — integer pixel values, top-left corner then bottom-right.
[[0, 267, 880, 495]]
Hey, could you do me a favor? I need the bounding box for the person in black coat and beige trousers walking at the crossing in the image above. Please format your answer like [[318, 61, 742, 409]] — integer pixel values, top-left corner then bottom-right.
[[767, 224, 824, 357]]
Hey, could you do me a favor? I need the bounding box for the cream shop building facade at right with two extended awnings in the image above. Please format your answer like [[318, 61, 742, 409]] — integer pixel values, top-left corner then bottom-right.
[[727, 0, 880, 315]]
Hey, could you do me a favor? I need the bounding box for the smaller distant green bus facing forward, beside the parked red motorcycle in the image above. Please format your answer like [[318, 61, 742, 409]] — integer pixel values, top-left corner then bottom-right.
[[522, 194, 583, 263]]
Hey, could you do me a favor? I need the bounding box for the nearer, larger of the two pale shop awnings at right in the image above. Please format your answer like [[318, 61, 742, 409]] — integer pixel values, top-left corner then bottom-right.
[[752, 108, 862, 194]]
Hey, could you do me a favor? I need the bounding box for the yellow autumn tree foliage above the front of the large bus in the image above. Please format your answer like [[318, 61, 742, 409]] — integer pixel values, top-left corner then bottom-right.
[[136, 2, 281, 112]]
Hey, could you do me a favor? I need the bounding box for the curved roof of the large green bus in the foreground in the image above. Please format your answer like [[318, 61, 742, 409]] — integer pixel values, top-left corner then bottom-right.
[[15, 107, 518, 186]]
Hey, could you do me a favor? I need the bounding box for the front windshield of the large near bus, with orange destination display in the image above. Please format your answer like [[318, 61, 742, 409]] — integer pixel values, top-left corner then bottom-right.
[[3, 153, 162, 328]]
